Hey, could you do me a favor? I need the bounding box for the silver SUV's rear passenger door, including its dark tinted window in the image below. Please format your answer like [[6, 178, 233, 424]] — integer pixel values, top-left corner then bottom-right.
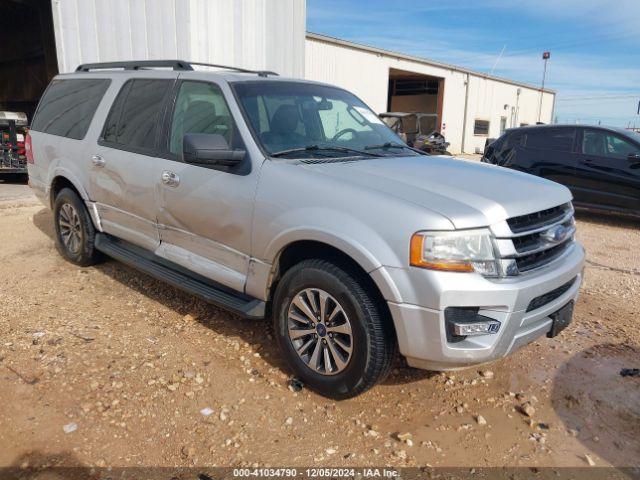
[[90, 72, 175, 250]]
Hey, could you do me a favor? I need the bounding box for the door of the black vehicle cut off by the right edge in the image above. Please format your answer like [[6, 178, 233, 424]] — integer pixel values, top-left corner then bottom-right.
[[574, 128, 640, 212]]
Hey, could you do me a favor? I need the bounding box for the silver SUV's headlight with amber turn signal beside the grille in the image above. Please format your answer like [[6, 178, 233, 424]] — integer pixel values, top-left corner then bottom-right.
[[410, 230, 499, 277]]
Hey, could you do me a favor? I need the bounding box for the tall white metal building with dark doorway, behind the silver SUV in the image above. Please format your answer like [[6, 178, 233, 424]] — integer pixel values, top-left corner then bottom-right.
[[0, 0, 306, 119]]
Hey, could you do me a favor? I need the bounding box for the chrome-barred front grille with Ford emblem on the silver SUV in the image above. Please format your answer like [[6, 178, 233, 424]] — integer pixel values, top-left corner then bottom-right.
[[492, 203, 575, 276]]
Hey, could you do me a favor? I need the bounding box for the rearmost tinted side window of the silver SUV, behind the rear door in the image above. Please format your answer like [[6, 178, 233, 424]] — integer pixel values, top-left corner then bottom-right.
[[31, 79, 111, 140]]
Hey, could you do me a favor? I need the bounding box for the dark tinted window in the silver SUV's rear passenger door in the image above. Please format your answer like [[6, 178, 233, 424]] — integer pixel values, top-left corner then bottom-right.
[[102, 79, 173, 150]]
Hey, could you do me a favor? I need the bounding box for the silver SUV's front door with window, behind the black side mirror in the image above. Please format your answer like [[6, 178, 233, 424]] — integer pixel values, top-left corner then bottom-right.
[[156, 78, 257, 291]]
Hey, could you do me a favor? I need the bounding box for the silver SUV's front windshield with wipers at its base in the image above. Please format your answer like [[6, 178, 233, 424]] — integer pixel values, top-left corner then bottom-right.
[[233, 81, 415, 158]]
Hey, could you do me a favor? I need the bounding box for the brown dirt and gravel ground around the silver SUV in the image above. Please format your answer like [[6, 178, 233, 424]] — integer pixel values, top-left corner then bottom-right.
[[0, 185, 640, 467]]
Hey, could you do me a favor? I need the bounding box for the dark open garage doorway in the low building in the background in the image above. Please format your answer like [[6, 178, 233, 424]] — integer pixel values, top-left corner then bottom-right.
[[387, 68, 444, 132]]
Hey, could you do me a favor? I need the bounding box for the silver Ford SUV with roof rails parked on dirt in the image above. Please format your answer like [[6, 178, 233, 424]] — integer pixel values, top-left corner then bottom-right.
[[27, 61, 584, 398]]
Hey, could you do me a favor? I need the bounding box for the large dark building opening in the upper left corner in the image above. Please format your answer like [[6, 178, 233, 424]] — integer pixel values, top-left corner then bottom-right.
[[0, 0, 58, 124]]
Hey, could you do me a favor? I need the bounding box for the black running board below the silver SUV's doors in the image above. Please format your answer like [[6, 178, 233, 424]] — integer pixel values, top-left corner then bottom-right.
[[95, 233, 266, 319]]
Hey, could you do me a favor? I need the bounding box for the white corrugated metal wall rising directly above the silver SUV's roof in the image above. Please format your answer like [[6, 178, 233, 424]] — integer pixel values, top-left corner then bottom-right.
[[51, 0, 306, 77]]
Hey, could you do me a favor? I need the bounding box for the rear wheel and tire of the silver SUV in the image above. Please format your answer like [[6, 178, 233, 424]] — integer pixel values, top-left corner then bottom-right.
[[53, 188, 101, 267]]
